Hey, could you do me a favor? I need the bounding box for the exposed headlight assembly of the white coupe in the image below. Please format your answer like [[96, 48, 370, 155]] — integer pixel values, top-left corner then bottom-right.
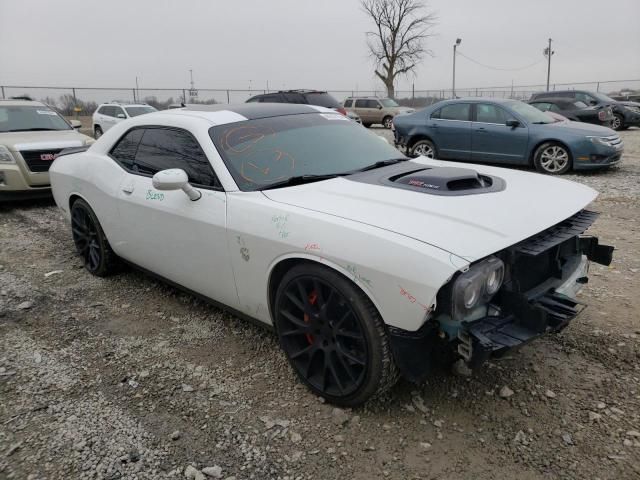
[[451, 257, 504, 320]]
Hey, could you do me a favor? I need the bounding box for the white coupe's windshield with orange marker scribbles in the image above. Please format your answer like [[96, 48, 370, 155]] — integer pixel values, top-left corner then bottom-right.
[[209, 113, 403, 191]]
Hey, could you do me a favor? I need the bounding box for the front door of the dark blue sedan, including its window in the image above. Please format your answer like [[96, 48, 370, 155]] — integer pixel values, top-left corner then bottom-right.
[[471, 103, 529, 163]]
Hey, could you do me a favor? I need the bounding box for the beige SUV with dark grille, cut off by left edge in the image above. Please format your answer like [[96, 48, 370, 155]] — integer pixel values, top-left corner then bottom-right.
[[0, 100, 94, 200]]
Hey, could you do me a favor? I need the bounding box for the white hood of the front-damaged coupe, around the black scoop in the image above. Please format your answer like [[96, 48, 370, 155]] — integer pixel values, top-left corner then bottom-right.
[[263, 157, 597, 262]]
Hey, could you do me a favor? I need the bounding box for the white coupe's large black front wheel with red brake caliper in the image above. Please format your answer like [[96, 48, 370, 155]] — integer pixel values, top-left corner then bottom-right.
[[274, 263, 398, 407]]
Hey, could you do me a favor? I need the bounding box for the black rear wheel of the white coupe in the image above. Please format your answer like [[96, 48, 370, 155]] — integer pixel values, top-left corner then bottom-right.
[[71, 199, 119, 277]]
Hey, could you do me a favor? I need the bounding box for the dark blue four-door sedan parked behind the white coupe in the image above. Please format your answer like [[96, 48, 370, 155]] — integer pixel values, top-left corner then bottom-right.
[[393, 98, 623, 174]]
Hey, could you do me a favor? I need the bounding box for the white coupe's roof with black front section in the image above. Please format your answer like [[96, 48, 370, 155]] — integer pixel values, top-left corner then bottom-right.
[[141, 103, 336, 125]]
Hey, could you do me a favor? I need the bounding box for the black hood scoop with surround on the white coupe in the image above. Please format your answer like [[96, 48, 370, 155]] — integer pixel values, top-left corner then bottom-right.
[[385, 167, 504, 195]]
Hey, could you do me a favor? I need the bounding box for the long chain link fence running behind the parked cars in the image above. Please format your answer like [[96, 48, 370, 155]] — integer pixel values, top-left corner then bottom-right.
[[0, 79, 640, 116]]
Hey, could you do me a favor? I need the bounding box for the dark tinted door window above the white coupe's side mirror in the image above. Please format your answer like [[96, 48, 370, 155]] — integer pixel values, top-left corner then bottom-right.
[[133, 128, 220, 188]]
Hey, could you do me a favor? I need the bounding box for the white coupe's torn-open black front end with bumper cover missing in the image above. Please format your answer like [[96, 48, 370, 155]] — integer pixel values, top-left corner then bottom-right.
[[389, 210, 614, 382]]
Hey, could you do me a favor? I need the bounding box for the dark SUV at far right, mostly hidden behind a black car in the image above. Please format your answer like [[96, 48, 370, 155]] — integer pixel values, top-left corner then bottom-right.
[[529, 90, 640, 130]]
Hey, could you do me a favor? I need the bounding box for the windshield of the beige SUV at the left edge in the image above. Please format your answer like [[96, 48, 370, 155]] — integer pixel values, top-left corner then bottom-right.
[[0, 105, 73, 132]]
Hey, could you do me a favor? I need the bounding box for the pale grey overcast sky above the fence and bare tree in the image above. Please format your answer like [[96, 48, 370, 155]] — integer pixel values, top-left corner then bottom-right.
[[0, 0, 640, 94]]
